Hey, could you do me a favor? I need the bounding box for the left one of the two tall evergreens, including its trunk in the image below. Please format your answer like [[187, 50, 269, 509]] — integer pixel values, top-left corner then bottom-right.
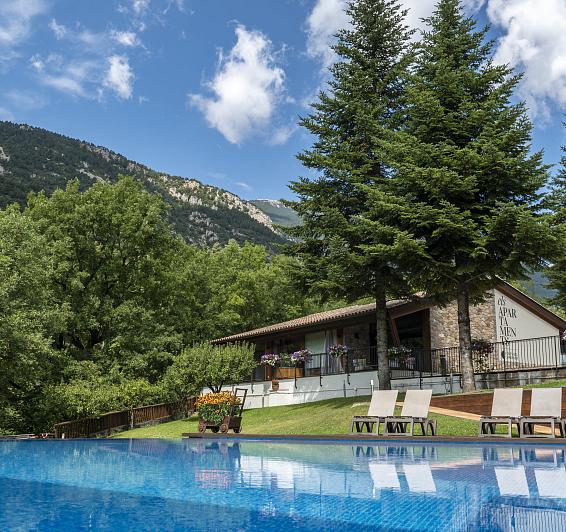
[[289, 0, 426, 389]]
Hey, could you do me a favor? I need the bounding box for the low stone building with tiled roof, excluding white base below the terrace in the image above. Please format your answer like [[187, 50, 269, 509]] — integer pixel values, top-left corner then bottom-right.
[[214, 282, 566, 380]]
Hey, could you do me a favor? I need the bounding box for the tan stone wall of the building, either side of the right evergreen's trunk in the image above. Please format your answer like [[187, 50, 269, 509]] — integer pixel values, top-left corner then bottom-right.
[[430, 295, 496, 349]]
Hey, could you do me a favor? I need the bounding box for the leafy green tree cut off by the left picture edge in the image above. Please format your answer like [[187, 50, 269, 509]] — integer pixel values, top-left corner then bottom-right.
[[0, 207, 65, 432]]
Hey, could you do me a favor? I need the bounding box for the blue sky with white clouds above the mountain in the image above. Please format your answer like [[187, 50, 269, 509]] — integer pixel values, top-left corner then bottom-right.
[[0, 0, 566, 199]]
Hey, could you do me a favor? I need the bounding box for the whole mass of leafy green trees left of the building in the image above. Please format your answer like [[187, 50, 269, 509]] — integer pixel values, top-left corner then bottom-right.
[[0, 177, 318, 432]]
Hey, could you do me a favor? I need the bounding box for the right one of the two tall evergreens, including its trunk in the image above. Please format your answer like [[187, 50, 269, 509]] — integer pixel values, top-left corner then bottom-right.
[[388, 0, 548, 391]]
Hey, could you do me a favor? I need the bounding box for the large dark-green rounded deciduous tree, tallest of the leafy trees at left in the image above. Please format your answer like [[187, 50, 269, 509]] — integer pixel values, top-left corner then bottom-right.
[[25, 178, 184, 380]]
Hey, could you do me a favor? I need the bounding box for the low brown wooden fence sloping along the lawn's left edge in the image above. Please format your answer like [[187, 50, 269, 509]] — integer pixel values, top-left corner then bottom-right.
[[54, 397, 195, 438]]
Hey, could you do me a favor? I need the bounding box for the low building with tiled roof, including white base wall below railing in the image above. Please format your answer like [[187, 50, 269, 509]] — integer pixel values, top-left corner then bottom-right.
[[214, 282, 566, 406]]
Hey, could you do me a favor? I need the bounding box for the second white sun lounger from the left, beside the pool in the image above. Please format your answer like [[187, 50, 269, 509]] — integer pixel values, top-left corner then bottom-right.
[[385, 390, 436, 436]]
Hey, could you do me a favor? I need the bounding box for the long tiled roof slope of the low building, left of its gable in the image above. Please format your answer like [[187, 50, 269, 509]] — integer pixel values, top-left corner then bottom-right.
[[212, 299, 408, 344]]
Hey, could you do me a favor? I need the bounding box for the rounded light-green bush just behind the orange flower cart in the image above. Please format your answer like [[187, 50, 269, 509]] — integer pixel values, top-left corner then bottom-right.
[[164, 343, 256, 397]]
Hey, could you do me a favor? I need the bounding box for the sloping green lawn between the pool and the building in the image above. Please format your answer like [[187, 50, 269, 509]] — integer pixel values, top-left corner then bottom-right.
[[114, 396, 484, 438]]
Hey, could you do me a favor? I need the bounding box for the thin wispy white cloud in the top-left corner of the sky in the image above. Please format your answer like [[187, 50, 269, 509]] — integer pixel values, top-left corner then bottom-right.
[[0, 0, 47, 55]]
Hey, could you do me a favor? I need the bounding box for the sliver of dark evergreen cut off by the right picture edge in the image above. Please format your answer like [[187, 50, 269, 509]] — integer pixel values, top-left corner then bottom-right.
[[547, 128, 566, 312]]
